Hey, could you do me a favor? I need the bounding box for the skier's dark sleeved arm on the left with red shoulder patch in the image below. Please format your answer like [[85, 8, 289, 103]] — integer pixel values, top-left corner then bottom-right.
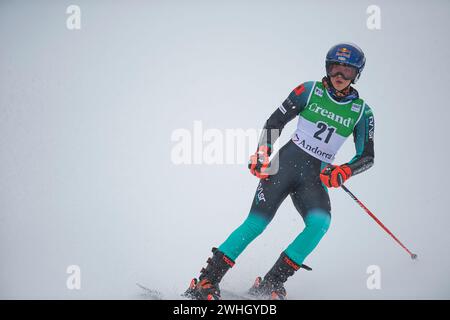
[[258, 81, 314, 155]]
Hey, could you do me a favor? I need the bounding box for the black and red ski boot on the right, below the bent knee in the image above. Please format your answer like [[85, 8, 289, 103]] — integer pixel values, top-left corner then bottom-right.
[[248, 252, 312, 300]]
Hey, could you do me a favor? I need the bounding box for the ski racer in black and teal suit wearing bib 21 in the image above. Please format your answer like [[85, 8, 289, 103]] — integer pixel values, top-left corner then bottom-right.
[[185, 43, 374, 300]]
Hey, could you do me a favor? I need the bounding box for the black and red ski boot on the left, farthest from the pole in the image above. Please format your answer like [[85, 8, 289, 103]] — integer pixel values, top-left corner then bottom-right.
[[184, 248, 234, 300]]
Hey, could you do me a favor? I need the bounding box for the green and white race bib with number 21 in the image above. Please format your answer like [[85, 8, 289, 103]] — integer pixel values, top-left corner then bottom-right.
[[292, 81, 365, 163]]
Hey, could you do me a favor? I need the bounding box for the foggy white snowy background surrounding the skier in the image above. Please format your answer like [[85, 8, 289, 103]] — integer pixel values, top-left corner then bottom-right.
[[0, 0, 450, 299]]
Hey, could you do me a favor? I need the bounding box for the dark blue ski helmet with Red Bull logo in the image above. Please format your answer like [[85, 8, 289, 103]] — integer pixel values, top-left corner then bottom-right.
[[325, 42, 366, 83]]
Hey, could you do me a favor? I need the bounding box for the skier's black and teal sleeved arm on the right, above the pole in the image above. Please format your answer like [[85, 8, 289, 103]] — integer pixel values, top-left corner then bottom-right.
[[347, 105, 375, 176]]
